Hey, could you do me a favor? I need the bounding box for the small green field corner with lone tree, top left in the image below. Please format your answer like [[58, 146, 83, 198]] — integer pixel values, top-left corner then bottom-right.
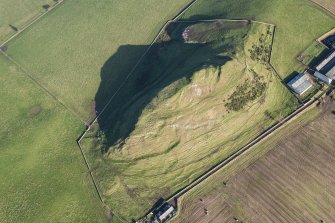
[[0, 0, 55, 43]]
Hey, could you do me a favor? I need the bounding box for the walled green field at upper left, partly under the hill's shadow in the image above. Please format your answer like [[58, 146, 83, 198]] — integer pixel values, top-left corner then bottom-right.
[[8, 0, 193, 120]]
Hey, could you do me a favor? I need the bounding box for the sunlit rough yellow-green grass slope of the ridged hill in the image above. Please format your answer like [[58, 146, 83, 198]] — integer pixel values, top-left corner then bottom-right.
[[83, 24, 296, 221]]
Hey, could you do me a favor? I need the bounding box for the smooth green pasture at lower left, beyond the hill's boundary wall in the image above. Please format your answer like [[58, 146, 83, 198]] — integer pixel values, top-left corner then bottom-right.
[[0, 55, 105, 222]]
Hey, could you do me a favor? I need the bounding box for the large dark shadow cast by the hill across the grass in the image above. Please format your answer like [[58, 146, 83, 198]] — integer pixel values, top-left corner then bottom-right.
[[95, 24, 247, 152]]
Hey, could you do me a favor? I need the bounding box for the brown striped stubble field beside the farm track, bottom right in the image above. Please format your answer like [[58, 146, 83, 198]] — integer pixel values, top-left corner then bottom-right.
[[173, 99, 335, 222]]
